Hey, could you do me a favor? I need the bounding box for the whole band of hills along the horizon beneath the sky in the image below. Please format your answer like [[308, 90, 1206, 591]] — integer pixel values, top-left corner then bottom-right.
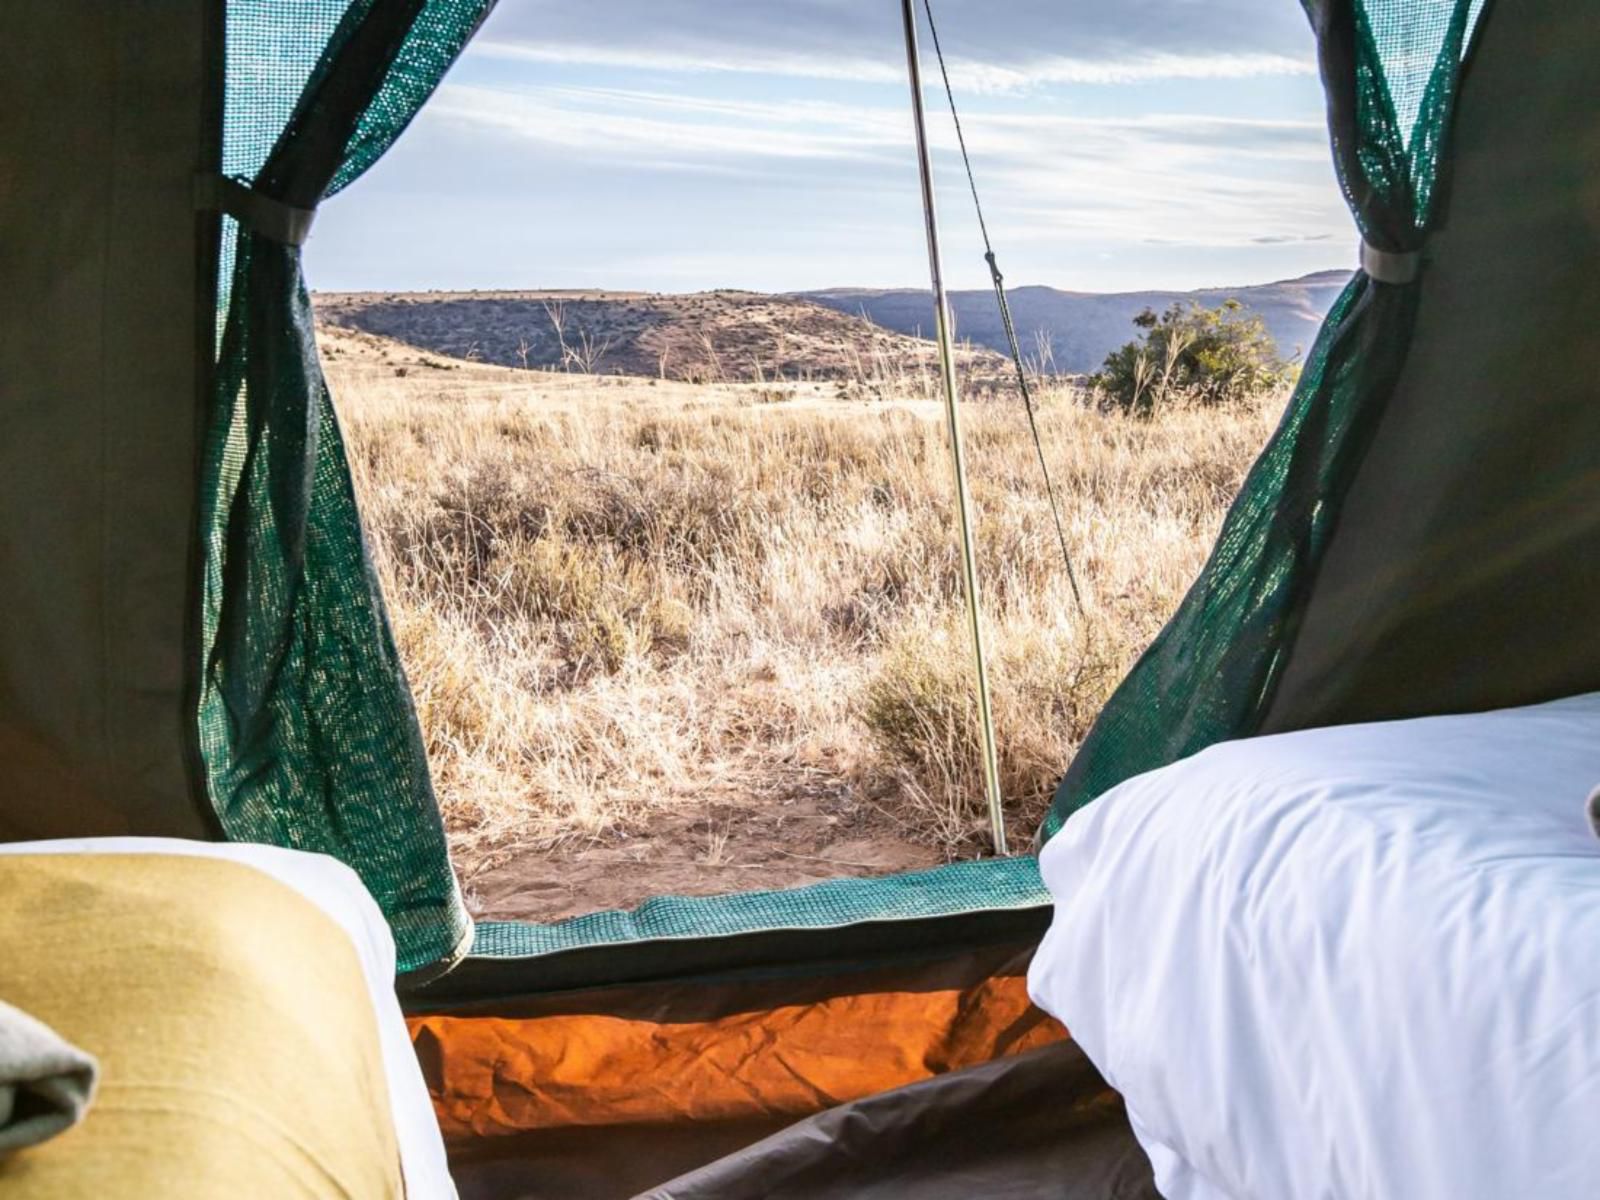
[[315, 270, 1350, 382]]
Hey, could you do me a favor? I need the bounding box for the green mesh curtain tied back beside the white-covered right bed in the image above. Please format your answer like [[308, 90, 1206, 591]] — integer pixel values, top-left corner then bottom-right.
[[1040, 0, 1483, 838]]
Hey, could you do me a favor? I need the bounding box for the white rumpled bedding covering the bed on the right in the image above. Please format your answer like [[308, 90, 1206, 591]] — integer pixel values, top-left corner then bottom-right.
[[1029, 694, 1600, 1200]]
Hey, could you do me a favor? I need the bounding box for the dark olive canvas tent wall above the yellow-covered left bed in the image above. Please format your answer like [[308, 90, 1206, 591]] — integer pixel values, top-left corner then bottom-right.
[[0, 0, 222, 840]]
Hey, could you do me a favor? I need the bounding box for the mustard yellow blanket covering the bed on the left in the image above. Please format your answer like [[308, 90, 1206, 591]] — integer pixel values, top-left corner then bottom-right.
[[0, 854, 403, 1200]]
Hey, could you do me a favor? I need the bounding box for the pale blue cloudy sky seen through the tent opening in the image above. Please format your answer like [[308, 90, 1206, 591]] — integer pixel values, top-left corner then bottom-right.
[[306, 0, 1355, 299]]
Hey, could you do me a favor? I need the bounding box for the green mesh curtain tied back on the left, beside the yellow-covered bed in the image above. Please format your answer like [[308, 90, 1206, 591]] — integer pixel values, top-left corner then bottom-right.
[[198, 0, 493, 971]]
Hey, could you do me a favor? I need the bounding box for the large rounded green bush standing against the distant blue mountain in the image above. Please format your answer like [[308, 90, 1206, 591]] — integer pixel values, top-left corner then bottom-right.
[[1090, 299, 1293, 413]]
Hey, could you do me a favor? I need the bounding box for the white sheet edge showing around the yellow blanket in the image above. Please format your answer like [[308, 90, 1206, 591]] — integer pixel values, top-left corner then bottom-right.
[[0, 837, 456, 1200]]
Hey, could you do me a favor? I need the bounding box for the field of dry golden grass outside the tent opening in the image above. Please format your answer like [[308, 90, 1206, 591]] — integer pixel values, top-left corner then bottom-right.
[[324, 334, 1278, 854]]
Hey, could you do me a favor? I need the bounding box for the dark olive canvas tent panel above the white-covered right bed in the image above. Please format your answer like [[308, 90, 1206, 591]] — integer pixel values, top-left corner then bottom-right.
[[1262, 0, 1600, 733]]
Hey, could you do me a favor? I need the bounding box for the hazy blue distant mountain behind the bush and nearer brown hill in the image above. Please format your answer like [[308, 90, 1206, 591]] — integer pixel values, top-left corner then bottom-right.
[[802, 270, 1350, 374]]
